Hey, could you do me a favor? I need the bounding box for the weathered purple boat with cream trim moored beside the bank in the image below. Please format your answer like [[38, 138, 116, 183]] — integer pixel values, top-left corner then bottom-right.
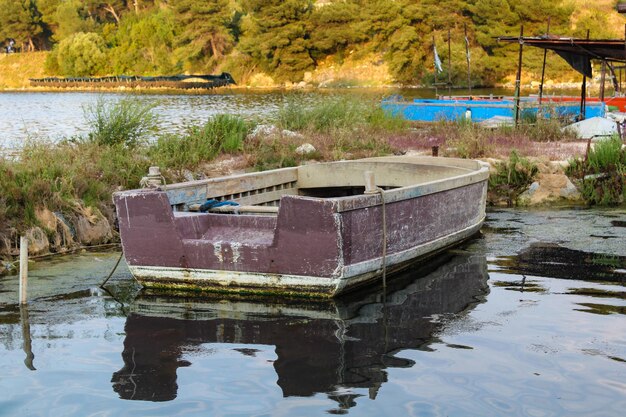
[[114, 157, 488, 297]]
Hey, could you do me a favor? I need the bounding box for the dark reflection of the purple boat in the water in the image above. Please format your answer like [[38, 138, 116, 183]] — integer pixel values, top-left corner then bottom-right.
[[112, 253, 488, 404]]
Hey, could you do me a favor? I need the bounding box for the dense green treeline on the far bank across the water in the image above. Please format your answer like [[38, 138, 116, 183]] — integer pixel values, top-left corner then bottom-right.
[[0, 0, 621, 85]]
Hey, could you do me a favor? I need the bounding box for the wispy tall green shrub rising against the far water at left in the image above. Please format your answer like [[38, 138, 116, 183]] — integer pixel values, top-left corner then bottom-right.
[[84, 98, 158, 147]]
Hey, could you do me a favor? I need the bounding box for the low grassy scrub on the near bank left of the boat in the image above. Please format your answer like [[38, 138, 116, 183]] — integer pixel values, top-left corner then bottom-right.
[[0, 141, 148, 234]]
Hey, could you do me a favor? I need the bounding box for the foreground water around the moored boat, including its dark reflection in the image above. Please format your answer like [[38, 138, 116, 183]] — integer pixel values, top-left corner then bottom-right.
[[0, 209, 626, 417]]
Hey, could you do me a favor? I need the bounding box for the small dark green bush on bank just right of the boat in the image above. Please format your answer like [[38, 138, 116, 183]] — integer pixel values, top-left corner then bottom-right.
[[489, 150, 539, 205]]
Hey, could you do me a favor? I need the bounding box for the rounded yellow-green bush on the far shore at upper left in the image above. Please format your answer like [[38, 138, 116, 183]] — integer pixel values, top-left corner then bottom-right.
[[55, 32, 106, 77]]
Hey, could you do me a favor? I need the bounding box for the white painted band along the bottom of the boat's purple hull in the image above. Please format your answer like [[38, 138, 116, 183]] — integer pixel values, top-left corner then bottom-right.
[[128, 217, 485, 296]]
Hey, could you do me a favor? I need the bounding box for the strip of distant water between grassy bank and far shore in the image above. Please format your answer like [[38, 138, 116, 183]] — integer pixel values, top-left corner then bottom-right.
[[0, 88, 511, 149]]
